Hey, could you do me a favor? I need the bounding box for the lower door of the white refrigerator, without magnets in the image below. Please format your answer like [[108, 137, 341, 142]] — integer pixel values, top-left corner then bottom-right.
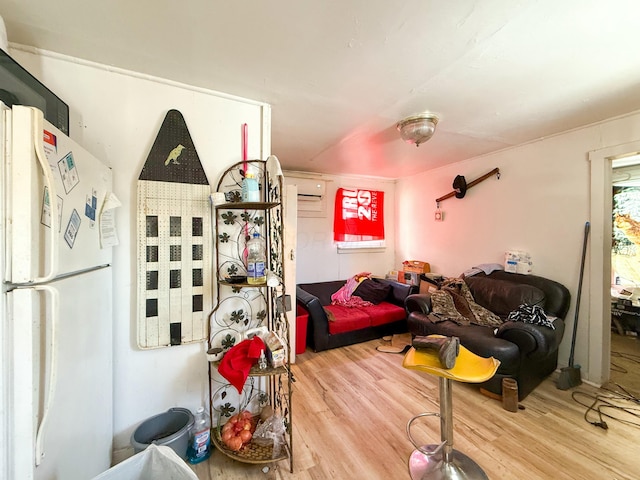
[[7, 267, 113, 480]]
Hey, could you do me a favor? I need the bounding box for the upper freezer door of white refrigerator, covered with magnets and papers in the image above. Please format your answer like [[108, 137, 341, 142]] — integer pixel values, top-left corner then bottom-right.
[[5, 106, 112, 284]]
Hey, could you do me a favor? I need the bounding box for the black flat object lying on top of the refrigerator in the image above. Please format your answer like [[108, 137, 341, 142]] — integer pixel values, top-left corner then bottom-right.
[[0, 49, 69, 135]]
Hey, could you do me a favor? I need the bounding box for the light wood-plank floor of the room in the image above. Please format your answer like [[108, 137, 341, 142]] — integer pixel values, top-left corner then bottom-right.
[[192, 338, 640, 480]]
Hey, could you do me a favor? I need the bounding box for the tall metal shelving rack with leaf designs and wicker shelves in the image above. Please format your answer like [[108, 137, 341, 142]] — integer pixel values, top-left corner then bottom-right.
[[208, 157, 293, 472]]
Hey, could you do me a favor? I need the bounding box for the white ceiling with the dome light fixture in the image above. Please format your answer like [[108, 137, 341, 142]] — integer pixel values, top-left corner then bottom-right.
[[0, 0, 640, 178]]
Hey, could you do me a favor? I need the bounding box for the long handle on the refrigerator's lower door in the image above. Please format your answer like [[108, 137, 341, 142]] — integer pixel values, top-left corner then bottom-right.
[[29, 285, 59, 466]]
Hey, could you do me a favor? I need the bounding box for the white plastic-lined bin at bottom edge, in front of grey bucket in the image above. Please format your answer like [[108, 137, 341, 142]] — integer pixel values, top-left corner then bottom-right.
[[93, 444, 198, 480]]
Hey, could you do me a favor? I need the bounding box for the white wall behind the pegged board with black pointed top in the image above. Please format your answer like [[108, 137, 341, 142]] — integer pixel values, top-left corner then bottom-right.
[[11, 48, 270, 460]]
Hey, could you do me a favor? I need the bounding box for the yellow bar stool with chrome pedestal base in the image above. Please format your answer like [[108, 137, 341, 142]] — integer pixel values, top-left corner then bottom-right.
[[402, 335, 500, 480]]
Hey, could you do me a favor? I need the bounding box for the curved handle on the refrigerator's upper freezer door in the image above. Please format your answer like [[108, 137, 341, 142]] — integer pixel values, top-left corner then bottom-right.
[[29, 108, 59, 283]]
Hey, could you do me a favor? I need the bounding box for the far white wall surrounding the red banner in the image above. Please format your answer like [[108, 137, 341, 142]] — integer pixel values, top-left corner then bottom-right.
[[284, 172, 398, 283]]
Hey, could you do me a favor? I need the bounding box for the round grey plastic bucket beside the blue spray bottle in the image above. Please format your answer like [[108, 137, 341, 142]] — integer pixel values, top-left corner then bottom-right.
[[131, 408, 194, 460]]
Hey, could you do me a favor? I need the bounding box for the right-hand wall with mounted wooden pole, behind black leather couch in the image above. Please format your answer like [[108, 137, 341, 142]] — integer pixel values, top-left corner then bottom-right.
[[396, 110, 640, 383]]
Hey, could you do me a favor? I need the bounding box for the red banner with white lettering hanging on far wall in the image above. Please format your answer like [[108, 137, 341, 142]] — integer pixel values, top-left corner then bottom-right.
[[333, 188, 384, 242]]
